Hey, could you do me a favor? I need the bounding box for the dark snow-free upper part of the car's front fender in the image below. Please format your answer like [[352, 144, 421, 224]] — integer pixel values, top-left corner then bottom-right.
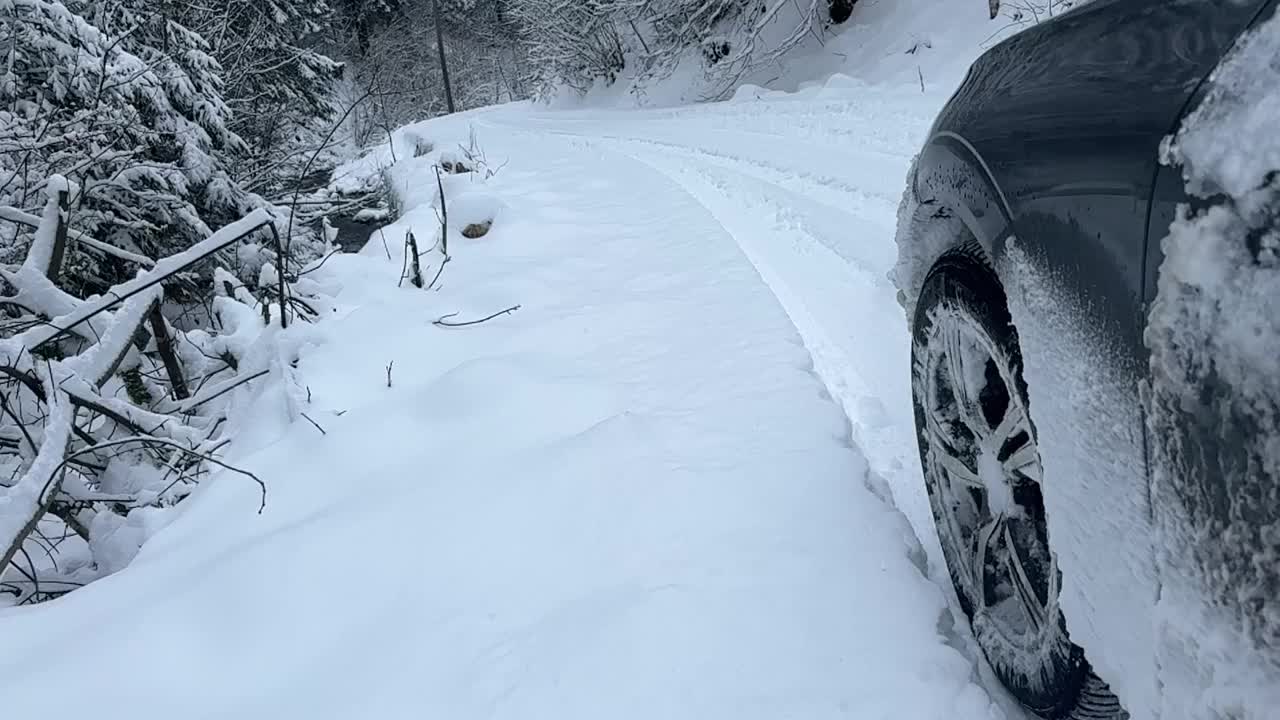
[[915, 0, 1262, 357]]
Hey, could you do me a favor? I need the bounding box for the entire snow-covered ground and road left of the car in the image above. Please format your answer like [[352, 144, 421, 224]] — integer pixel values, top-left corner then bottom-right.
[[0, 81, 1016, 720]]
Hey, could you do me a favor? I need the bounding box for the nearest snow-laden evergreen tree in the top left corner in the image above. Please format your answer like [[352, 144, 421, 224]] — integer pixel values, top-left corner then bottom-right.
[[0, 0, 252, 279]]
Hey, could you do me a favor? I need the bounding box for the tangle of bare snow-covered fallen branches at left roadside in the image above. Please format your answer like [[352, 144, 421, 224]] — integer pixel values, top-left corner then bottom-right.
[[0, 184, 328, 603]]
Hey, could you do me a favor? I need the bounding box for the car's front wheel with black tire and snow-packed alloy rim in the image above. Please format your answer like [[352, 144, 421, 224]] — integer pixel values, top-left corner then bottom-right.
[[911, 242, 1126, 720]]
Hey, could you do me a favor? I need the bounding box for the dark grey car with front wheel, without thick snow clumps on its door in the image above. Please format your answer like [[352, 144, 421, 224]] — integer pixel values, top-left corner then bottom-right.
[[897, 0, 1280, 719]]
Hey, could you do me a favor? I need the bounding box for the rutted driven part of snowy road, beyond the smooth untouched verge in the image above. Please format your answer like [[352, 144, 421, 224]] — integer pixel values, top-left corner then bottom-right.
[[475, 77, 962, 594]]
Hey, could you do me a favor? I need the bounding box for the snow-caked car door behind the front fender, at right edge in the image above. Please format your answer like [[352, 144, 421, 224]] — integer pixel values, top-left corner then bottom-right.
[[1147, 7, 1280, 717]]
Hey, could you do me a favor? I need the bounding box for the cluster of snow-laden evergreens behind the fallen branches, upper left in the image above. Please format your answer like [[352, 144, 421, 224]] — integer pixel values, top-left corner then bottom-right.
[[0, 0, 337, 291]]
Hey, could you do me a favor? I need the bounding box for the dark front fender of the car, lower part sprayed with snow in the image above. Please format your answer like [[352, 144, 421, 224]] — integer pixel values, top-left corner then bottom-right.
[[911, 0, 1265, 717]]
